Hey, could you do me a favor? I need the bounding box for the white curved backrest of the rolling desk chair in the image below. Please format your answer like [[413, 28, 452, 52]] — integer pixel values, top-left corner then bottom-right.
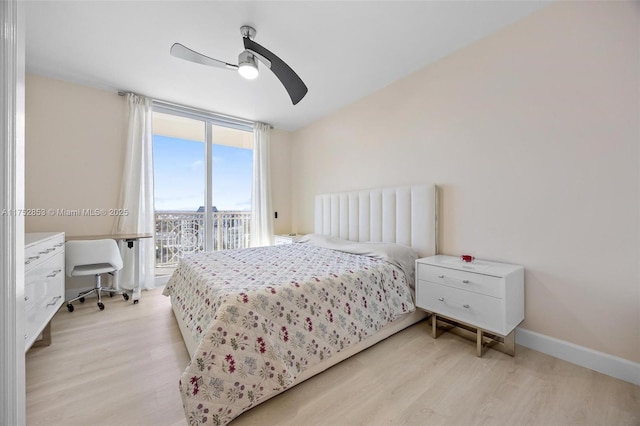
[[65, 239, 122, 277]]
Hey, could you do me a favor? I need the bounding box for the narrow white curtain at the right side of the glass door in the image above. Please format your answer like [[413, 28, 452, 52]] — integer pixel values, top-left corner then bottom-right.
[[251, 123, 273, 247]]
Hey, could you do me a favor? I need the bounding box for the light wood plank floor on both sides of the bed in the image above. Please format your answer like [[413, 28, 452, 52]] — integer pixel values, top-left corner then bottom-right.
[[26, 290, 640, 426]]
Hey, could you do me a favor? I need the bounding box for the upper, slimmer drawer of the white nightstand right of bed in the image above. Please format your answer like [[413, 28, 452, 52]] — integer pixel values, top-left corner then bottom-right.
[[418, 263, 504, 298]]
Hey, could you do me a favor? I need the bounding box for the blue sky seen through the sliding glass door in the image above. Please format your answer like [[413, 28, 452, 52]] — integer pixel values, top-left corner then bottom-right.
[[153, 135, 253, 211]]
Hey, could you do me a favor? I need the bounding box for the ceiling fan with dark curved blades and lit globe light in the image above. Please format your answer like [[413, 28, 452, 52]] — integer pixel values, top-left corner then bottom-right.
[[170, 25, 308, 105]]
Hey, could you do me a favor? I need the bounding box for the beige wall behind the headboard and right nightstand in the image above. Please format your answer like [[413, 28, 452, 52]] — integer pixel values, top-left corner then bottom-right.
[[292, 2, 640, 362]]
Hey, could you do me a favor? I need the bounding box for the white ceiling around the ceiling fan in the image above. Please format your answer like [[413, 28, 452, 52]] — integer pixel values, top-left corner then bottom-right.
[[26, 0, 548, 130]]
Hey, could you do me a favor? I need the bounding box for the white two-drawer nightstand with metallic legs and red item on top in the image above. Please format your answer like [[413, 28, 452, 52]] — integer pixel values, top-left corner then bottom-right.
[[416, 255, 524, 356]]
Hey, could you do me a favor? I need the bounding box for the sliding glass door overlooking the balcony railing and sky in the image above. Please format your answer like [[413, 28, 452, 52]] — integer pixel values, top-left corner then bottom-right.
[[153, 109, 253, 268]]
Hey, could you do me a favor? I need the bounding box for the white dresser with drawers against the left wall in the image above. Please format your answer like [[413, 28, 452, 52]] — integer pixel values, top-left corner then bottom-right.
[[24, 232, 64, 351]]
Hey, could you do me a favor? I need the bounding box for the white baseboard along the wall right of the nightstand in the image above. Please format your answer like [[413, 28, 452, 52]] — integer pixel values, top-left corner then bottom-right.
[[516, 327, 640, 386]]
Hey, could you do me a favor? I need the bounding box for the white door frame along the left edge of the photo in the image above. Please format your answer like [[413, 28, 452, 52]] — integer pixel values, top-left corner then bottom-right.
[[0, 0, 26, 425]]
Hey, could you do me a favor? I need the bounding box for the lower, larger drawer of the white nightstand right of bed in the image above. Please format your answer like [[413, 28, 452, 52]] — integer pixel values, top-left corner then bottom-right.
[[416, 280, 507, 335]]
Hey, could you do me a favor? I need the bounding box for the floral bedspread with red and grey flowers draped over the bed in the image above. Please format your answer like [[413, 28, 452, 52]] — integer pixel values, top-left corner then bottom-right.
[[164, 244, 415, 425]]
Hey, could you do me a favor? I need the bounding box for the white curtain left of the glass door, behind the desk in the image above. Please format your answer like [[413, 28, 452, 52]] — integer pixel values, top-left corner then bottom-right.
[[114, 93, 155, 289]]
